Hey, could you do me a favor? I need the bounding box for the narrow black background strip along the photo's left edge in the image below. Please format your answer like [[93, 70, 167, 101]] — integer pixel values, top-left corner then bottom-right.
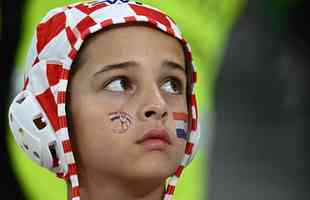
[[0, 0, 25, 200]]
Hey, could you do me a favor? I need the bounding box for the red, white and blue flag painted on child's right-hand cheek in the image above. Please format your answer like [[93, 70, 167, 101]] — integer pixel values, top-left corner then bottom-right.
[[172, 112, 188, 140]]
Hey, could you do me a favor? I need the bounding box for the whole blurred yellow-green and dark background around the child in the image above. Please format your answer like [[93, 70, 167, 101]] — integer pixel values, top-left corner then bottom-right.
[[0, 0, 310, 200]]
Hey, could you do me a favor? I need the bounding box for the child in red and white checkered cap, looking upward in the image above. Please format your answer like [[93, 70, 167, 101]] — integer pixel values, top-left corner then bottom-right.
[[9, 0, 199, 200]]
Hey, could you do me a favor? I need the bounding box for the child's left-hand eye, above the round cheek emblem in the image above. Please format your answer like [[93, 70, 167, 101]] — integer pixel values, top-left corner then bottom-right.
[[104, 77, 132, 92]]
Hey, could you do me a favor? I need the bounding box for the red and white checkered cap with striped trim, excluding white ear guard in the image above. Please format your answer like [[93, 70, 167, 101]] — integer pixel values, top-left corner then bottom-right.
[[14, 0, 199, 200]]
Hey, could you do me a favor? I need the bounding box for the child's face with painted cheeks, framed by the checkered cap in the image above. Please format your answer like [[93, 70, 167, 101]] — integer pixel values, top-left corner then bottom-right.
[[69, 26, 187, 180]]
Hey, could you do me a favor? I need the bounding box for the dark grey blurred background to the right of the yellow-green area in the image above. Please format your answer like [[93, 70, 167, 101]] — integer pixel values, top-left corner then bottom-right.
[[208, 0, 310, 200]]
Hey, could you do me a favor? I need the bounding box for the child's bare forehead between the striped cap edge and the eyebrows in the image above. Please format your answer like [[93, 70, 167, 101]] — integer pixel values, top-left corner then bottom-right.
[[76, 23, 184, 63]]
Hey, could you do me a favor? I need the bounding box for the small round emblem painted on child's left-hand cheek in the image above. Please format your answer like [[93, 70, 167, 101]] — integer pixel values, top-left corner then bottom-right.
[[109, 112, 132, 133]]
